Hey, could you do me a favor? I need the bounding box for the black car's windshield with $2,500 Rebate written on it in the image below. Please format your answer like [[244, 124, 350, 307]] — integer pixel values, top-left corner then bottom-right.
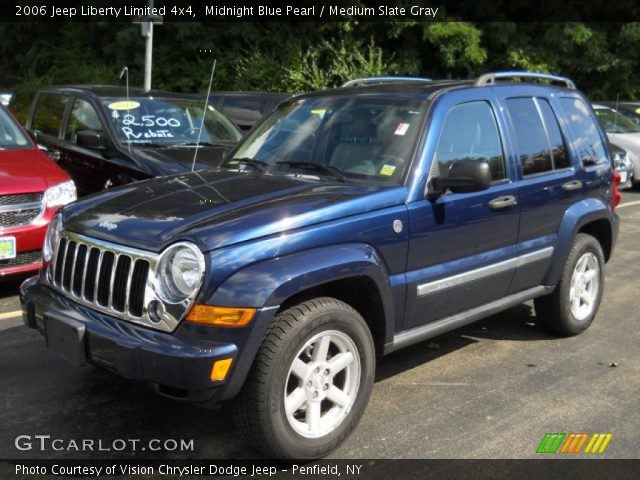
[[102, 97, 242, 146]]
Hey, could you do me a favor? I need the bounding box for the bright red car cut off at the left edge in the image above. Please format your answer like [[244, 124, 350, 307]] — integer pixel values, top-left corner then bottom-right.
[[0, 107, 76, 278]]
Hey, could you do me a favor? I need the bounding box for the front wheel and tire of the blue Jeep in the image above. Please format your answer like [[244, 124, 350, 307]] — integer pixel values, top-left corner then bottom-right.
[[234, 297, 375, 459]]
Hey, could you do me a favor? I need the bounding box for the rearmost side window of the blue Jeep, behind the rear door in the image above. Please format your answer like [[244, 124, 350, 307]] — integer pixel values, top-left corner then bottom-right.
[[560, 97, 607, 167]]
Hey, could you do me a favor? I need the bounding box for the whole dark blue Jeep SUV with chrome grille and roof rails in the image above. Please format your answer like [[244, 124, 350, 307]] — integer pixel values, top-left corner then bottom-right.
[[21, 72, 620, 458]]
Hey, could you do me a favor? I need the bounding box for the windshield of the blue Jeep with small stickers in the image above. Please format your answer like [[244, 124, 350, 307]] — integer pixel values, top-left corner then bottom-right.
[[228, 96, 426, 183]]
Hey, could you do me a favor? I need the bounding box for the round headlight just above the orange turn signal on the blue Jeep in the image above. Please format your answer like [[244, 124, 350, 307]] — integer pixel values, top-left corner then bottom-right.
[[157, 242, 204, 303]]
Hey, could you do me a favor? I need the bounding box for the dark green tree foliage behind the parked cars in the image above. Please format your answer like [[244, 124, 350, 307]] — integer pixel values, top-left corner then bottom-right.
[[0, 21, 640, 99]]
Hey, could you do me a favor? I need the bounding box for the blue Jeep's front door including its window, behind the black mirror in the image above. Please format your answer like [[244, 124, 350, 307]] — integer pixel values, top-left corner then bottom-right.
[[403, 96, 520, 330]]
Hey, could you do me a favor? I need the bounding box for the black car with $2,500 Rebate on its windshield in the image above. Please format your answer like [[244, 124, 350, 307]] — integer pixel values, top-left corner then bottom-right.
[[9, 86, 242, 194]]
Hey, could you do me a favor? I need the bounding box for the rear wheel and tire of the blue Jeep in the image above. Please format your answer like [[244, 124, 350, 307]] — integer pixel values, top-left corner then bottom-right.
[[534, 233, 605, 336]]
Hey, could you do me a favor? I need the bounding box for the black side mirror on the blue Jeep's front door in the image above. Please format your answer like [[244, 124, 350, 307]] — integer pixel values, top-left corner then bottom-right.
[[429, 158, 491, 198]]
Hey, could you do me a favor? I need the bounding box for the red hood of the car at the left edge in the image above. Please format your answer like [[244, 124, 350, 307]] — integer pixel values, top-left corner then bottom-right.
[[0, 148, 69, 195]]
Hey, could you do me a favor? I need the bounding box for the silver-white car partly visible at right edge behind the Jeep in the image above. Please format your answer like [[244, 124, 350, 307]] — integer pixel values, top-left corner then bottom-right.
[[592, 103, 640, 185]]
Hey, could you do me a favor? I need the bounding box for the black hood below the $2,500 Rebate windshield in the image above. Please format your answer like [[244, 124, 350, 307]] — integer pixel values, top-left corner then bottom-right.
[[132, 145, 233, 176]]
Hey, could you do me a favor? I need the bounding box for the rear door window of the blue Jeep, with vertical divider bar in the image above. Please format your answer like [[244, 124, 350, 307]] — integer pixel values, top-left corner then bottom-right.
[[506, 98, 570, 176]]
